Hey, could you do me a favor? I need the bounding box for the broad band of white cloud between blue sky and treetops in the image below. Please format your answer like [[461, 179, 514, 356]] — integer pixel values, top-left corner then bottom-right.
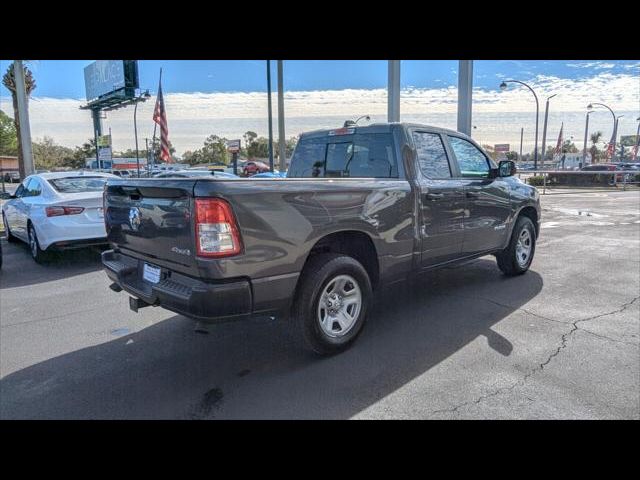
[[0, 72, 640, 153]]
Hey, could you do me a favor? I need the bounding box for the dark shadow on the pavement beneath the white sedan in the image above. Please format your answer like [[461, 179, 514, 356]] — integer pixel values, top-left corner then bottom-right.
[[0, 238, 102, 288]]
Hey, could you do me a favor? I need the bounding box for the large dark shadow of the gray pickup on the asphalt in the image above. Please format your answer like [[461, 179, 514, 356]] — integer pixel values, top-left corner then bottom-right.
[[0, 259, 543, 419]]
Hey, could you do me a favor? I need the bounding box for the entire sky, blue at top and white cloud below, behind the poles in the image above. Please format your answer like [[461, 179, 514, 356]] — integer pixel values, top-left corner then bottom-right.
[[0, 60, 640, 155]]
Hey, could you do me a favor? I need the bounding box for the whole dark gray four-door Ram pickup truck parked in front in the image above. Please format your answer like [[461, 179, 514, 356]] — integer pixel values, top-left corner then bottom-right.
[[102, 123, 540, 354]]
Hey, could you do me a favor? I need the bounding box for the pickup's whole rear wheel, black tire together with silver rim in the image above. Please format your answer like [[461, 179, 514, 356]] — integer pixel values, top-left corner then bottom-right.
[[290, 253, 372, 355]]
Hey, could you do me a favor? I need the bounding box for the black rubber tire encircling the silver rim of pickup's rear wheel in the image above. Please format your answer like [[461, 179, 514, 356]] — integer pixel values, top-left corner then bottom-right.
[[289, 253, 372, 355]]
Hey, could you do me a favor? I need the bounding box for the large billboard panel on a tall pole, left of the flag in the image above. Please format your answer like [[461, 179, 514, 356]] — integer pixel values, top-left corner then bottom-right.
[[84, 60, 138, 101]]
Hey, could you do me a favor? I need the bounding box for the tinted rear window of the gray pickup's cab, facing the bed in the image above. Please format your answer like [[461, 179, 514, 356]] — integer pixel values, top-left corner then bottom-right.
[[287, 129, 398, 178]]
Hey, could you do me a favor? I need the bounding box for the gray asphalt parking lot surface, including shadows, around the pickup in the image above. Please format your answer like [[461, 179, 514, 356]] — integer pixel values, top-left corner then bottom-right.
[[0, 191, 640, 419]]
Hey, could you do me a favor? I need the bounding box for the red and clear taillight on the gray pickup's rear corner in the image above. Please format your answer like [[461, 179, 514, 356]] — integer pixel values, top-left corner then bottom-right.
[[195, 198, 242, 257]]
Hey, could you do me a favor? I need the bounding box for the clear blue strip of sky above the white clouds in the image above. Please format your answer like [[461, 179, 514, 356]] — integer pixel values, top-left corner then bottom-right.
[[1, 60, 638, 99]]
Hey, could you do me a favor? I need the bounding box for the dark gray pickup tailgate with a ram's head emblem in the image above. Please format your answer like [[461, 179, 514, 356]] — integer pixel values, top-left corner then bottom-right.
[[105, 179, 197, 273]]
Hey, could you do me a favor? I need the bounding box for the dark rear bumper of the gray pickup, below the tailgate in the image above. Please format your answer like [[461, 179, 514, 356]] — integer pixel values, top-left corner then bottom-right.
[[102, 250, 253, 321]]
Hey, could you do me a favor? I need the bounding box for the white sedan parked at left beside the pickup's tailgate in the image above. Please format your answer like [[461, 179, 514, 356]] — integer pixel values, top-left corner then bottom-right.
[[2, 171, 118, 262]]
